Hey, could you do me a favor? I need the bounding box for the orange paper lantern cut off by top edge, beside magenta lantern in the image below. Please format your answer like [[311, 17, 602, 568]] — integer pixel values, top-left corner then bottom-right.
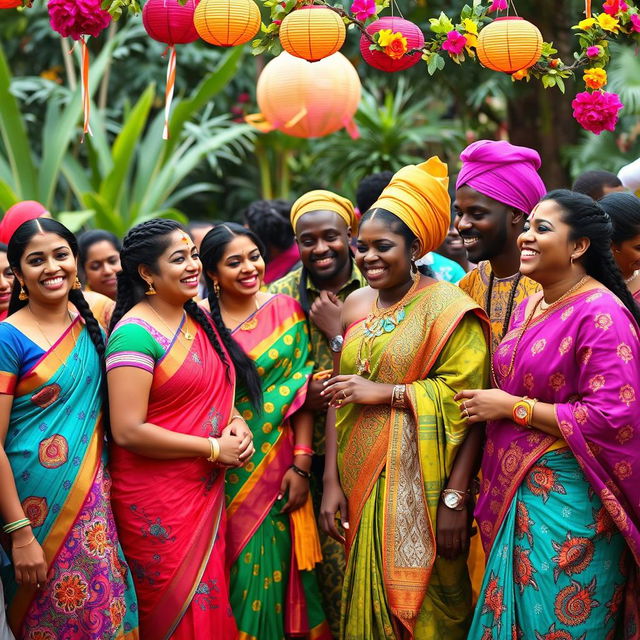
[[193, 0, 261, 47]]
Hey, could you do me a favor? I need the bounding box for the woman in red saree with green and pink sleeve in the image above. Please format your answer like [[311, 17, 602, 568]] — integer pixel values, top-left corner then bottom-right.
[[107, 219, 259, 640]]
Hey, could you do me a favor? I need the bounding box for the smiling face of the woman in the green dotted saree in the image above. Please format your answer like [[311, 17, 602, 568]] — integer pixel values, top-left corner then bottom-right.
[[208, 235, 265, 297]]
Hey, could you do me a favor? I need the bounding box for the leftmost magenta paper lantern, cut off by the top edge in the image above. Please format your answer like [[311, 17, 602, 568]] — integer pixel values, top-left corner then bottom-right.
[[142, 0, 199, 46]]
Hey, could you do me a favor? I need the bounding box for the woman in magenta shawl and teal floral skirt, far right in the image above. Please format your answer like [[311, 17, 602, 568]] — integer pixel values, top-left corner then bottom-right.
[[459, 191, 640, 640]]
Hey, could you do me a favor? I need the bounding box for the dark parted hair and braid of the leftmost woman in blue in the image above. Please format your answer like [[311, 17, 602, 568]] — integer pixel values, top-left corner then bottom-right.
[[7, 218, 109, 422]]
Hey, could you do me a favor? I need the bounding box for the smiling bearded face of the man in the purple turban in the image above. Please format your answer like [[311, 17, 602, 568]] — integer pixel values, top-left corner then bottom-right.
[[453, 185, 522, 262]]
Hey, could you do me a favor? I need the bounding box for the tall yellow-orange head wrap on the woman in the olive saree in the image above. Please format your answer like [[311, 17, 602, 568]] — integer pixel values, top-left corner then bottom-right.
[[371, 156, 451, 256]]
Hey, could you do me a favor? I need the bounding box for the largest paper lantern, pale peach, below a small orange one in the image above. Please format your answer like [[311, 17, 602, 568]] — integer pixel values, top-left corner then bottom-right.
[[252, 51, 361, 138]]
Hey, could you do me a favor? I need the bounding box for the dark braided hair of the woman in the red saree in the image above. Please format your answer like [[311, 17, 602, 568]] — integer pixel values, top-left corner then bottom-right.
[[110, 218, 258, 402]]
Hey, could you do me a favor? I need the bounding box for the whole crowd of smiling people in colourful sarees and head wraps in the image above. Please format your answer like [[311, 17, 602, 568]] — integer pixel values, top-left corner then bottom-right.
[[0, 140, 640, 640]]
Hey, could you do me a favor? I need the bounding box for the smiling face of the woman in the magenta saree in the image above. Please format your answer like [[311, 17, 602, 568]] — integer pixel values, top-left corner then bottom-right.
[[518, 200, 589, 286]]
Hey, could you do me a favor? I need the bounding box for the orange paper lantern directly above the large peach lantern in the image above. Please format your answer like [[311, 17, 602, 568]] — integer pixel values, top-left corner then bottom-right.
[[280, 5, 347, 62]]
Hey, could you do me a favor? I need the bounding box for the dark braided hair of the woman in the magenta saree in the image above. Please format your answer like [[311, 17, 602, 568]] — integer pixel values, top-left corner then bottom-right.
[[542, 189, 640, 324]]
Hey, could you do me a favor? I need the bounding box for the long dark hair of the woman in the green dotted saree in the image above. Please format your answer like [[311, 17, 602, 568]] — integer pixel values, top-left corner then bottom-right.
[[200, 222, 264, 410]]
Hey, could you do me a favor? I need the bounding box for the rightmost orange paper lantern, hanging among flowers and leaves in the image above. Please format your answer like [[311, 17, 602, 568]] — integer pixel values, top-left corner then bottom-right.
[[476, 17, 542, 73]]
